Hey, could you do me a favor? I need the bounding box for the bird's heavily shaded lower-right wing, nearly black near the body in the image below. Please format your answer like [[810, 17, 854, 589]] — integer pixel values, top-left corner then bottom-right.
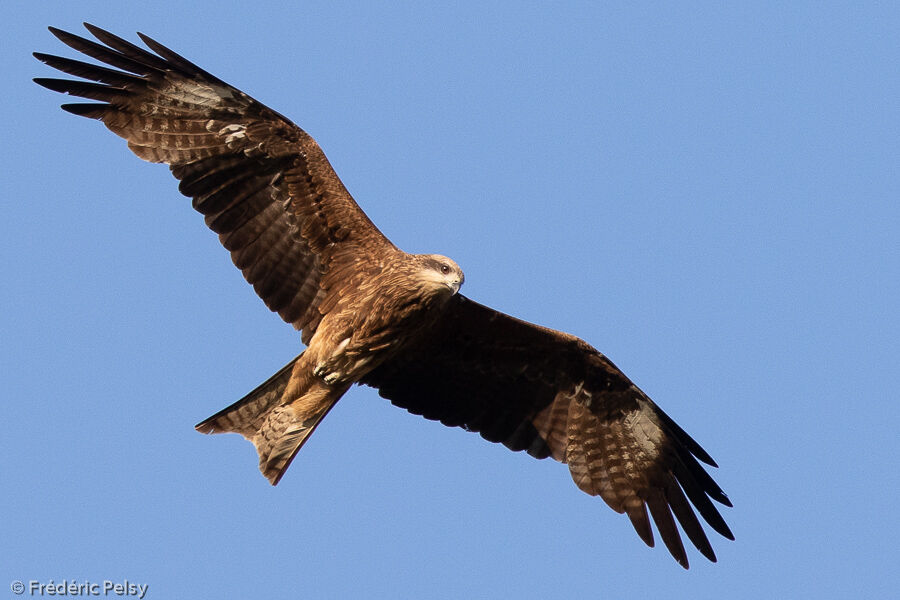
[[362, 296, 734, 568]]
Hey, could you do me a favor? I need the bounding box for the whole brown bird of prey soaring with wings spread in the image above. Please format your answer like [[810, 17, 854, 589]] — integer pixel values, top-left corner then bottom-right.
[[35, 24, 734, 568]]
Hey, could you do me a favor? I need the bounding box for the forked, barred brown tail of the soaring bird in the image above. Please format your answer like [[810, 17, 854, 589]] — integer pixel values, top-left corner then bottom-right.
[[195, 354, 347, 485]]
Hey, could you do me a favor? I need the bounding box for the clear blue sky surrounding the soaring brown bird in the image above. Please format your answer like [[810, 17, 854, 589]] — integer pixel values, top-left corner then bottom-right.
[[0, 0, 900, 600]]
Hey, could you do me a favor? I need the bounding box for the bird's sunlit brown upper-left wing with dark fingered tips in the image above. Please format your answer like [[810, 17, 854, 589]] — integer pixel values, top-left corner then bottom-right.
[[35, 23, 393, 341]]
